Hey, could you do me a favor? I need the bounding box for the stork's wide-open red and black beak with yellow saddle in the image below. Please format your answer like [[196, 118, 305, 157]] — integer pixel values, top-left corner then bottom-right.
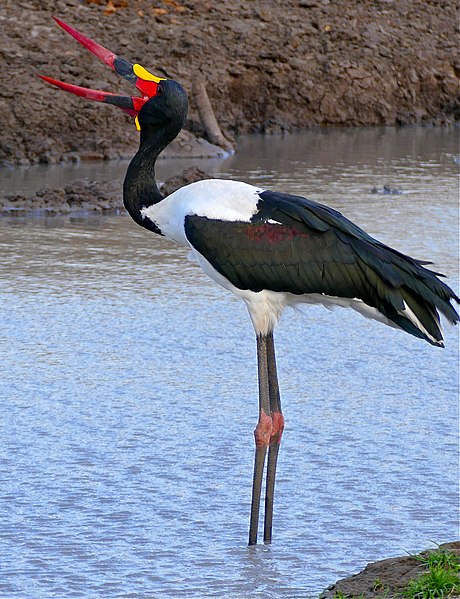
[[39, 17, 164, 128]]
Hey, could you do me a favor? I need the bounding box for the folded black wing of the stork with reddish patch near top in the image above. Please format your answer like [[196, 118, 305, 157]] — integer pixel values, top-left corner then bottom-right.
[[185, 191, 459, 344]]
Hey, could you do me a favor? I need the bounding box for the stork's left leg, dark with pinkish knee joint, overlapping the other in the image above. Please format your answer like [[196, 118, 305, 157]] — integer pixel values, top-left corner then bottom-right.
[[249, 335, 272, 545]]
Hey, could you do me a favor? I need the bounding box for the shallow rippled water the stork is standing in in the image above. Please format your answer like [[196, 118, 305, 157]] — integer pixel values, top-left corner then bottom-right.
[[0, 129, 459, 599]]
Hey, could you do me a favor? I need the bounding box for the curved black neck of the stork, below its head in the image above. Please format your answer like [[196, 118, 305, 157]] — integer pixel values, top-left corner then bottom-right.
[[123, 121, 181, 233]]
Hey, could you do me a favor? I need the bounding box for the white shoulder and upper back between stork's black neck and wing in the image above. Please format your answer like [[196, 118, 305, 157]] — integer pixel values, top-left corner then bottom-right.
[[142, 179, 263, 246]]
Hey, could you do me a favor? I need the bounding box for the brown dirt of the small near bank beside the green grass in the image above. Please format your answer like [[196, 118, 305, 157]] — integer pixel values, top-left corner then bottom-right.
[[321, 541, 460, 599]]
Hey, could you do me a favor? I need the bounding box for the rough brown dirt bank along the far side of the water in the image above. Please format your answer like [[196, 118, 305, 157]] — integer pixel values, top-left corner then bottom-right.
[[0, 0, 460, 164]]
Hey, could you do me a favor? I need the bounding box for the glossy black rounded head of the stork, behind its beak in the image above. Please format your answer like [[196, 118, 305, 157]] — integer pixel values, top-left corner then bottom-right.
[[137, 79, 188, 134]]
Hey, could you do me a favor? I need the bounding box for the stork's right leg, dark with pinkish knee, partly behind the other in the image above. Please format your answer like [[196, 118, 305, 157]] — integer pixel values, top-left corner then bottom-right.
[[264, 333, 284, 543]]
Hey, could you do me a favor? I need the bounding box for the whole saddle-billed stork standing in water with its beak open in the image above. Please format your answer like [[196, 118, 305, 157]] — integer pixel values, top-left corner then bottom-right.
[[42, 19, 459, 545]]
